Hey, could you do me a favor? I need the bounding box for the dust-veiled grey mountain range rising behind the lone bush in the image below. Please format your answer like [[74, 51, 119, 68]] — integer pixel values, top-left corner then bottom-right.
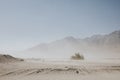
[[19, 30, 120, 58]]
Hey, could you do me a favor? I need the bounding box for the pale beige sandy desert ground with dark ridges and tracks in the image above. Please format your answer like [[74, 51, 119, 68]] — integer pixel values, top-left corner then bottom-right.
[[0, 60, 120, 80]]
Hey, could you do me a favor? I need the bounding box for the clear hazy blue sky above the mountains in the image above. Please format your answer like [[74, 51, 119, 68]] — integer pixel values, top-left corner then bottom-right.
[[0, 0, 120, 50]]
